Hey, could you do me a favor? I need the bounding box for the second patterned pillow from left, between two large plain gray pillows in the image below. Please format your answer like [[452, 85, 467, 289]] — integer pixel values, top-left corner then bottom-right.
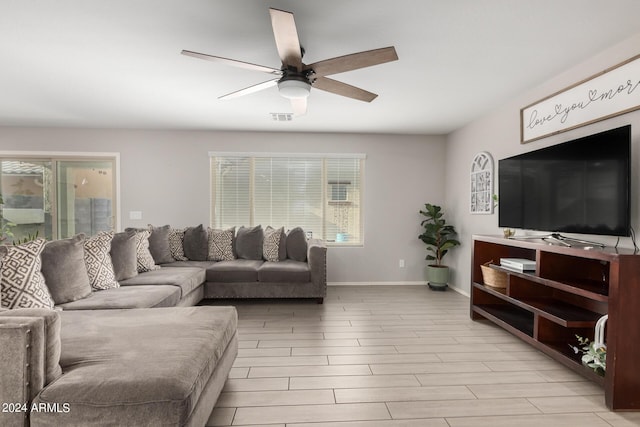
[[84, 231, 120, 291]]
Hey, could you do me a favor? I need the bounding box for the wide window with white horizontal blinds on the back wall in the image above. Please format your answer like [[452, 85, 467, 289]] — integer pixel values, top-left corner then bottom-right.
[[210, 153, 365, 245]]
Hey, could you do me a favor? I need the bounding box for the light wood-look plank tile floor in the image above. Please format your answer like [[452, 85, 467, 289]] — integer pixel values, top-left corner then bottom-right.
[[208, 286, 640, 427]]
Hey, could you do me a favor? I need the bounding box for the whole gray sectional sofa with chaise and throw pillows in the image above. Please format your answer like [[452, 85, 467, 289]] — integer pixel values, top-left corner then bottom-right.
[[0, 226, 326, 426]]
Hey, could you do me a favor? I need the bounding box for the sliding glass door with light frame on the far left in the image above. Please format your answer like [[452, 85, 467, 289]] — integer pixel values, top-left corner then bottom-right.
[[0, 154, 116, 243]]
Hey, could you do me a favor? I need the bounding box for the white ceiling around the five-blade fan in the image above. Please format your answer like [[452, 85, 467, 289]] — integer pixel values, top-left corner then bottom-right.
[[0, 0, 640, 134]]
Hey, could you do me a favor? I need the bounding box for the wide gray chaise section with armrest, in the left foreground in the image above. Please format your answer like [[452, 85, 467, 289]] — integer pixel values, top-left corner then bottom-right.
[[0, 307, 238, 427]]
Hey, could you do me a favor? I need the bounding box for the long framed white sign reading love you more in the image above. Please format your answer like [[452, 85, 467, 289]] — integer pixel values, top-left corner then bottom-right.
[[520, 55, 640, 144]]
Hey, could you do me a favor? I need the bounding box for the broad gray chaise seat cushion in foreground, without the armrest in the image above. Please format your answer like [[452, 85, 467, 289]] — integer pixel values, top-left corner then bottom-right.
[[31, 307, 237, 426]]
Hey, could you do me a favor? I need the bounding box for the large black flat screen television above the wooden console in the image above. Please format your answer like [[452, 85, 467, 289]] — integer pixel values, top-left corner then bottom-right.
[[498, 125, 631, 236]]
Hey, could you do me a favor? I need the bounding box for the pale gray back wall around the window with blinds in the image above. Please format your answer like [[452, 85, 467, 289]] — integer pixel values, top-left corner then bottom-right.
[[0, 127, 445, 282]]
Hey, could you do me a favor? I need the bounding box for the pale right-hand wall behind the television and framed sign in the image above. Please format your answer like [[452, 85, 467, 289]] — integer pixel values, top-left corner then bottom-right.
[[445, 34, 640, 292]]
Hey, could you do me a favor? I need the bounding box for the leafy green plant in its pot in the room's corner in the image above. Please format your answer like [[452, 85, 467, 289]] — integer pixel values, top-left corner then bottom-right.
[[418, 203, 460, 291]]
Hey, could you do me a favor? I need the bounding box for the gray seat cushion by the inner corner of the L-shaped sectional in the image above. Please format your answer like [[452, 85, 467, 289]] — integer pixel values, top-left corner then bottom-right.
[[120, 267, 205, 298]]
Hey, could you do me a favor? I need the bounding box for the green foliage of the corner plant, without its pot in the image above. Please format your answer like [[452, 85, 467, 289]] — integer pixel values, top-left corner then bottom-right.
[[418, 203, 460, 266]]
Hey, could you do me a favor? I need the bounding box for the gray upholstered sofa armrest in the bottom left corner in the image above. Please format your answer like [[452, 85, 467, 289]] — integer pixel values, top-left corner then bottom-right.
[[0, 309, 62, 426]]
